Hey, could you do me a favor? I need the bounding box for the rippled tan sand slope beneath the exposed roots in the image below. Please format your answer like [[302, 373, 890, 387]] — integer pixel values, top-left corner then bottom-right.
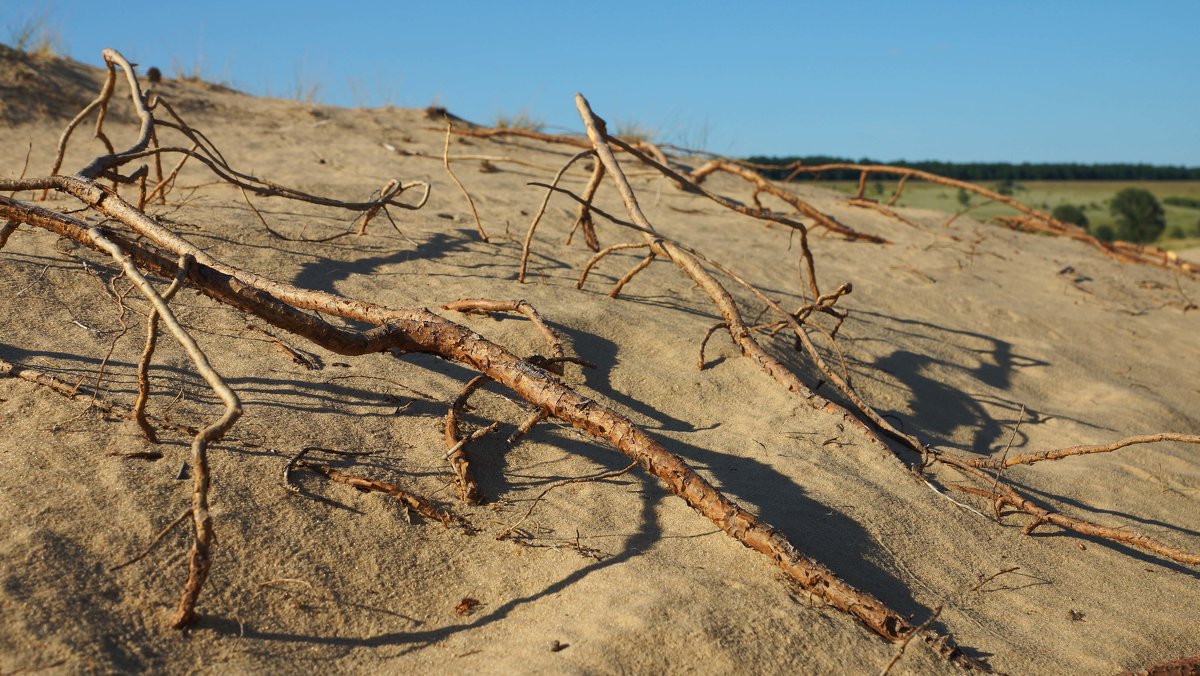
[[0, 46, 1200, 674]]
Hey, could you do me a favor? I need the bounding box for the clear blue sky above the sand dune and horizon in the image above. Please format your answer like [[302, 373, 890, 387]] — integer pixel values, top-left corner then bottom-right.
[[9, 0, 1200, 166]]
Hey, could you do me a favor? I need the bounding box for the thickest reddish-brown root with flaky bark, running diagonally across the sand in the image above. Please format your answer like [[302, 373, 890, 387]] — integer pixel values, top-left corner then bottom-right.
[[0, 184, 926, 640]]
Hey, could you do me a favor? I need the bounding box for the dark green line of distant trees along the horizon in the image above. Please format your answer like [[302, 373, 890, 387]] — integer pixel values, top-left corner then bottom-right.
[[746, 155, 1200, 183]]
